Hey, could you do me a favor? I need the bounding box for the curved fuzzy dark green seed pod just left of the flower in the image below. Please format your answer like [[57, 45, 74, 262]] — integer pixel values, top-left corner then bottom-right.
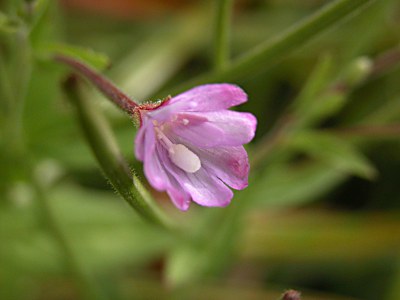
[[65, 77, 173, 229]]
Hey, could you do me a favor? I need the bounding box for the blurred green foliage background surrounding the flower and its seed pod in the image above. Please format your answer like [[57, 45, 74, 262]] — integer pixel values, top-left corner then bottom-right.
[[0, 0, 400, 300]]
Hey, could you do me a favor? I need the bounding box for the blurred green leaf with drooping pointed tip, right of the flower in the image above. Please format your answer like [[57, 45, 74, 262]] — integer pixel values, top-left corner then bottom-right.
[[286, 131, 377, 179]]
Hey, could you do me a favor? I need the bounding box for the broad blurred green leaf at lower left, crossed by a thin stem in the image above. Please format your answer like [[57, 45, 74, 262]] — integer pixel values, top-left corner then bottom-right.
[[0, 184, 172, 275]]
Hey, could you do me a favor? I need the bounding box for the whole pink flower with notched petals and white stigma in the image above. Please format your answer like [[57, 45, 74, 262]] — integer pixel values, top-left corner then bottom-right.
[[135, 84, 257, 210]]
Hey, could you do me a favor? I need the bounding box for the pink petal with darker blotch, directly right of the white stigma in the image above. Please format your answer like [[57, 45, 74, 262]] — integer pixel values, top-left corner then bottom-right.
[[196, 146, 250, 190]]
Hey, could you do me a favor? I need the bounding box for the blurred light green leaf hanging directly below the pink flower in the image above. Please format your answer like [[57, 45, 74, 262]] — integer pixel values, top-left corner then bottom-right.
[[166, 199, 241, 287]]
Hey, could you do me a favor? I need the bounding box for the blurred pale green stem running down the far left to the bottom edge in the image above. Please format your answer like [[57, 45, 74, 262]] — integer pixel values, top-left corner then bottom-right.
[[1, 22, 102, 300]]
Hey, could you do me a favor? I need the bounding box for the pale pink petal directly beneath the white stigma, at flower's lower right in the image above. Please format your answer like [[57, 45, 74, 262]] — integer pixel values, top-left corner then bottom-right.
[[159, 145, 233, 206]]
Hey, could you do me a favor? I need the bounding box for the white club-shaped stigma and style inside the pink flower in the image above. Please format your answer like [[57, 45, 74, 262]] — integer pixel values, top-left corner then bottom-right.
[[153, 122, 201, 173]]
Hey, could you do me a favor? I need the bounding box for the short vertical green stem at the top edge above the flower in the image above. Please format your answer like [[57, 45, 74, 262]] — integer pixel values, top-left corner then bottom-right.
[[214, 0, 233, 71]]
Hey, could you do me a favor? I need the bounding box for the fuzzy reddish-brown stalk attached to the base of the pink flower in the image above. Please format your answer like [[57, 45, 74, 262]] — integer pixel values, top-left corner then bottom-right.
[[55, 54, 138, 115]]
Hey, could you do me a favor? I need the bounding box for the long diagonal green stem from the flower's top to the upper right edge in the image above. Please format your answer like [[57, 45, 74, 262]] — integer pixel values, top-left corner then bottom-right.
[[160, 0, 376, 94]]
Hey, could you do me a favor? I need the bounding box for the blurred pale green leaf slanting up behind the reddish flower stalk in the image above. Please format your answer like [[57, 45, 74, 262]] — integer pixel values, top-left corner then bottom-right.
[[110, 8, 208, 101]]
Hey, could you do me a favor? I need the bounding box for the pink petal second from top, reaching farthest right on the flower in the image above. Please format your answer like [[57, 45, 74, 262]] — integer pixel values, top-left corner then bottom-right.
[[171, 110, 257, 148]]
